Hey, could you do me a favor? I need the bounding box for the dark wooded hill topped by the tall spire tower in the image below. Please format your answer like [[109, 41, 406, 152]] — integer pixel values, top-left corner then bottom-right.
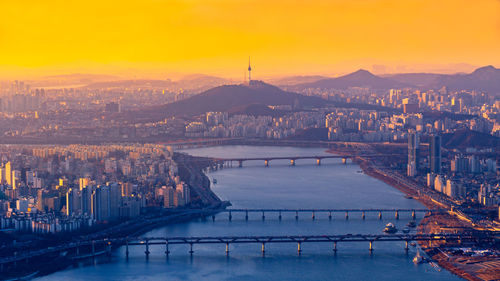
[[124, 80, 394, 120]]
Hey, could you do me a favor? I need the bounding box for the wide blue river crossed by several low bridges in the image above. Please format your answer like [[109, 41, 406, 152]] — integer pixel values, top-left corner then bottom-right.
[[40, 146, 459, 281]]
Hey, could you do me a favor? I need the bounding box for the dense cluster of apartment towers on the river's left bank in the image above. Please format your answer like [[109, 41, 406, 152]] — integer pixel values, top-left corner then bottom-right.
[[0, 144, 191, 233]]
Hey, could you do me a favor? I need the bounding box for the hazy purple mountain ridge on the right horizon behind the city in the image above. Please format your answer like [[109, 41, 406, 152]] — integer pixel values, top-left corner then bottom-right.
[[291, 65, 500, 95]]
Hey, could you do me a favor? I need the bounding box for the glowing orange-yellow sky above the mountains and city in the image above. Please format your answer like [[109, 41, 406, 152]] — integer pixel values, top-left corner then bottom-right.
[[0, 0, 500, 78]]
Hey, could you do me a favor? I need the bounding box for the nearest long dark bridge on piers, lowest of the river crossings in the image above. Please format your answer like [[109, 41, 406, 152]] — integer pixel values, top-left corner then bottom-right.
[[0, 231, 500, 271]]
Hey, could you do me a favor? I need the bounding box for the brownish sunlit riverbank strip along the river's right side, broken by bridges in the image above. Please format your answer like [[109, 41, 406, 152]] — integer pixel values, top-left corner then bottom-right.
[[328, 144, 500, 281]]
